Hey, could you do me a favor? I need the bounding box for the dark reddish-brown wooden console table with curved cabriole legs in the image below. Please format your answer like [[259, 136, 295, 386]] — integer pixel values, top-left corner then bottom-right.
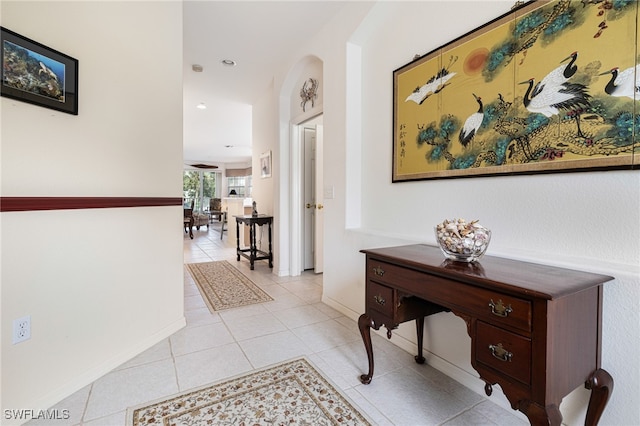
[[358, 245, 613, 426]]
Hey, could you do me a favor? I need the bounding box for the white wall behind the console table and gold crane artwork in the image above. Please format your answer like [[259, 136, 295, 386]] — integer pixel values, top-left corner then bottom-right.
[[350, 2, 640, 424]]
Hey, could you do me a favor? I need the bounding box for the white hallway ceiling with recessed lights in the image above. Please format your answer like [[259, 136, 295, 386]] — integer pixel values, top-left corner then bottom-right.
[[183, 0, 344, 167]]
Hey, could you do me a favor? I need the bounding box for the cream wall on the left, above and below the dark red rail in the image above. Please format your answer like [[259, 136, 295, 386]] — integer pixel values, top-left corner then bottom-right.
[[0, 1, 184, 424]]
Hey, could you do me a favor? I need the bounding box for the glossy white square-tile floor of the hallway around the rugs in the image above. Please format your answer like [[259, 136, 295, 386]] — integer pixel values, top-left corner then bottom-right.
[[30, 224, 527, 426]]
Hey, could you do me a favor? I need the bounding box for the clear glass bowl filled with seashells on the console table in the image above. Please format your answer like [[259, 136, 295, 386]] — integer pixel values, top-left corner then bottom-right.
[[434, 219, 491, 262]]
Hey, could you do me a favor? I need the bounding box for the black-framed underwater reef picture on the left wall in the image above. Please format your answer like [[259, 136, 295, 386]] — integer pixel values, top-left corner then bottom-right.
[[0, 27, 78, 115]]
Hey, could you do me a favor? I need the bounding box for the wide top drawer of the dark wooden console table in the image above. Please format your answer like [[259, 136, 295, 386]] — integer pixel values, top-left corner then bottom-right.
[[367, 259, 531, 332]]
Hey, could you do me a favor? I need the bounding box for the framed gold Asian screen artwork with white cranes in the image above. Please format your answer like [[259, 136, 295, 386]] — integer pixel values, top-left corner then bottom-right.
[[392, 0, 640, 182]]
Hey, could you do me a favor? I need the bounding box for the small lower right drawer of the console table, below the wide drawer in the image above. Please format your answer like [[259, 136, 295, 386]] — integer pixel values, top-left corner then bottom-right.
[[474, 321, 531, 385]]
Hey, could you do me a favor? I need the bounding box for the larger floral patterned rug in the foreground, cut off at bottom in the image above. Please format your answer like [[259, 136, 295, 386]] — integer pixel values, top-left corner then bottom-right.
[[127, 357, 371, 426]]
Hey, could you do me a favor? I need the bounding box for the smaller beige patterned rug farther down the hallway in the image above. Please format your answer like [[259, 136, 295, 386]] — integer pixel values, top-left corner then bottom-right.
[[186, 260, 273, 312]]
